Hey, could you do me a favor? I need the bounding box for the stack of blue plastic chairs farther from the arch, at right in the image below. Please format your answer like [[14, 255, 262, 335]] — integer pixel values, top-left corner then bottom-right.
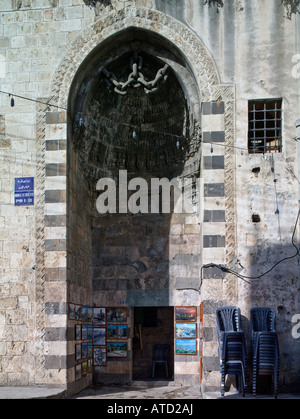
[[250, 307, 279, 398]]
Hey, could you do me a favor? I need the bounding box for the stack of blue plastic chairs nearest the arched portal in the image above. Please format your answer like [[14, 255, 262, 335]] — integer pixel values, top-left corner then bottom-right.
[[216, 306, 247, 397]]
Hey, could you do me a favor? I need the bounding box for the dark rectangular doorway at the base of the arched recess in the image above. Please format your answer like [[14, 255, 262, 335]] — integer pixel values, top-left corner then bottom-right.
[[132, 307, 174, 381]]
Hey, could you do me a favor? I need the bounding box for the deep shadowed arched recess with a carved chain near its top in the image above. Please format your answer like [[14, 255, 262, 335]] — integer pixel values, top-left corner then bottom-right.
[[68, 28, 201, 383]]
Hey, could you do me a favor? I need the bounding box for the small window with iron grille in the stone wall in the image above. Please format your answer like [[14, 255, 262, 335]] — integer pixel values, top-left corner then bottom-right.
[[248, 99, 282, 153]]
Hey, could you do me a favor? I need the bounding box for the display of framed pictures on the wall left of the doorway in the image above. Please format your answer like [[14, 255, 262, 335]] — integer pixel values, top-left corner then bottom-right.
[[69, 304, 128, 381]]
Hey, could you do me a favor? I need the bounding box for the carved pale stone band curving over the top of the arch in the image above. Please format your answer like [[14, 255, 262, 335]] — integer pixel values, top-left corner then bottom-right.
[[51, 7, 220, 107]]
